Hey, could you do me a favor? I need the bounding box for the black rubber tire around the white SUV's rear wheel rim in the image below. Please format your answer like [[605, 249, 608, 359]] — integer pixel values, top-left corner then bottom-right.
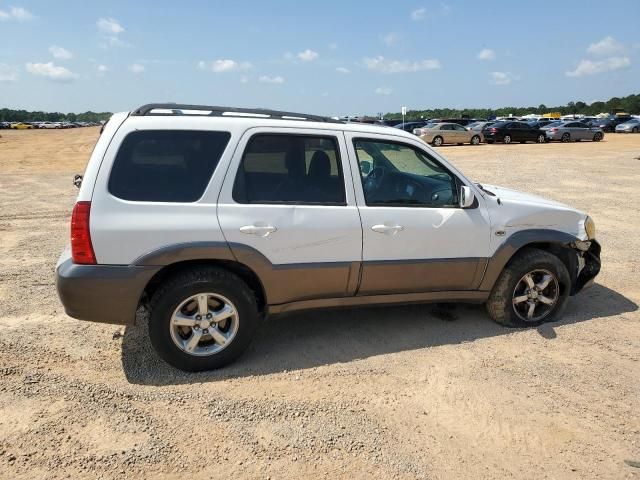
[[149, 267, 260, 372]]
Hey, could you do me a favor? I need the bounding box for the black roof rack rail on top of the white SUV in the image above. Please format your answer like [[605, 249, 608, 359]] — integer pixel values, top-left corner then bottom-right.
[[131, 103, 344, 123]]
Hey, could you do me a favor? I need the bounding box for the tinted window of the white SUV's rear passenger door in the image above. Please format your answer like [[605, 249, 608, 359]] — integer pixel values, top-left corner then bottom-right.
[[233, 135, 345, 205]]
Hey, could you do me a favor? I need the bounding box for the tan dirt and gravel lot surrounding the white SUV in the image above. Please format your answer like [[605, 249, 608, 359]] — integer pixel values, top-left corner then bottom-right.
[[0, 128, 640, 480]]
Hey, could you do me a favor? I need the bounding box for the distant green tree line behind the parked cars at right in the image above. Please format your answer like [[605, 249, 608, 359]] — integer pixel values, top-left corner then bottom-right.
[[384, 94, 640, 120]]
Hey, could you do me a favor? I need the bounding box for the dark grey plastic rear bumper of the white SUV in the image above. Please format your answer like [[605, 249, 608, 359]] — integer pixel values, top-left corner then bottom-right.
[[56, 250, 160, 324]]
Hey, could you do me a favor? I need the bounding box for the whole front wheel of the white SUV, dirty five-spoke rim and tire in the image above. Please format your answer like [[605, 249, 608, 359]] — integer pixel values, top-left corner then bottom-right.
[[487, 249, 571, 327]]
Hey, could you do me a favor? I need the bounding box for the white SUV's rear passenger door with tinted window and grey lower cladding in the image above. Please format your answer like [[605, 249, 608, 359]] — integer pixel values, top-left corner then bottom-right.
[[218, 127, 362, 304]]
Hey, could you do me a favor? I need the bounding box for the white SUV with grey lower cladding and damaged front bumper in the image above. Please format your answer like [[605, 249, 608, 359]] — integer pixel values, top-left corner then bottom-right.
[[56, 104, 600, 370]]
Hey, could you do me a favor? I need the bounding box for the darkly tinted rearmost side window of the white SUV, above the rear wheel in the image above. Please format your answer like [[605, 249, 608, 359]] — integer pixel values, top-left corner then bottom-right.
[[109, 130, 231, 202]]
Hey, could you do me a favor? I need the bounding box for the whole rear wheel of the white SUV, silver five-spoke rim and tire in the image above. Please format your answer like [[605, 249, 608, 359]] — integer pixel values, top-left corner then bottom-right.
[[149, 267, 259, 371]]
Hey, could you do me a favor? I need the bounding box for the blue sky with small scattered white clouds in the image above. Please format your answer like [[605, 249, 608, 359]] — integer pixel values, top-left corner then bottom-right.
[[0, 0, 640, 115]]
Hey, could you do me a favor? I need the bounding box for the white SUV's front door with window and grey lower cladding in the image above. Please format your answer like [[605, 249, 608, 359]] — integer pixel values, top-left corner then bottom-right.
[[346, 133, 490, 295]]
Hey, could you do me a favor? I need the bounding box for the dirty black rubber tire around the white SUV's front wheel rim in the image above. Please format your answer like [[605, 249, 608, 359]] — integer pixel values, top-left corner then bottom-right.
[[486, 248, 571, 328]]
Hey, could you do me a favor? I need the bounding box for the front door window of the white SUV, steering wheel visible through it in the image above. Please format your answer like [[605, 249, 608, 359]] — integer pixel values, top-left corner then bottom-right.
[[354, 139, 458, 207]]
